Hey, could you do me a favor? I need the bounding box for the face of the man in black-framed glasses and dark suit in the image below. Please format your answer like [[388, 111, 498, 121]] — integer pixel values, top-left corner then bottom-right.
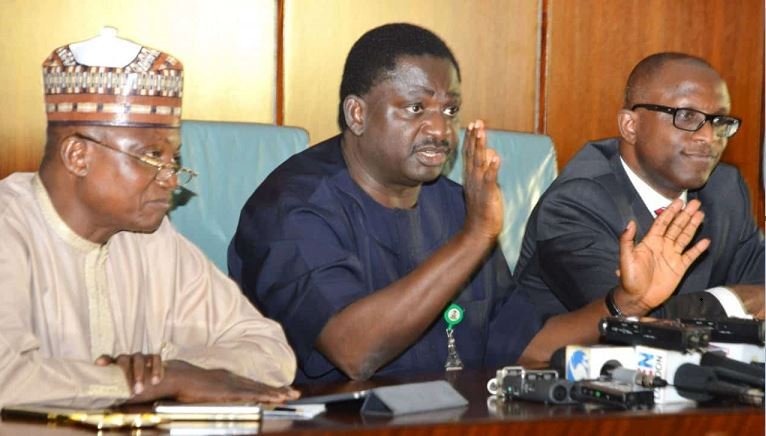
[[635, 62, 730, 197]]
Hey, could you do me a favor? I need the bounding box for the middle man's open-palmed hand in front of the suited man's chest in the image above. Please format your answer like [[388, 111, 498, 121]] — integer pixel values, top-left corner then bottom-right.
[[619, 200, 710, 313]]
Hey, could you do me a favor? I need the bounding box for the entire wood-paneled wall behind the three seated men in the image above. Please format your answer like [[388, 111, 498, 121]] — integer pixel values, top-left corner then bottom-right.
[[0, 0, 764, 224]]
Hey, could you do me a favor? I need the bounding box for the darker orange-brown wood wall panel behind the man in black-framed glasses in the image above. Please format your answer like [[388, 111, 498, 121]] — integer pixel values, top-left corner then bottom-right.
[[543, 0, 764, 225]]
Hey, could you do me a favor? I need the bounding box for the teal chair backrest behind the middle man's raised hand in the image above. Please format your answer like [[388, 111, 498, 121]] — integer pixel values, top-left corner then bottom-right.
[[445, 130, 557, 271]]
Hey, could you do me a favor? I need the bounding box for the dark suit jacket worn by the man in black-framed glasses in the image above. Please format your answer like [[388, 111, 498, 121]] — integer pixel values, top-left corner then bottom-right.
[[515, 139, 764, 318]]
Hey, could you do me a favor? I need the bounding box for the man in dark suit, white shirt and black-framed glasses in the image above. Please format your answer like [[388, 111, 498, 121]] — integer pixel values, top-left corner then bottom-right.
[[515, 53, 764, 318]]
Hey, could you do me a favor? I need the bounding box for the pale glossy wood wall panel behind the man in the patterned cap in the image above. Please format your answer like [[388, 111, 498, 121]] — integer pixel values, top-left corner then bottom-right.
[[0, 0, 277, 178]]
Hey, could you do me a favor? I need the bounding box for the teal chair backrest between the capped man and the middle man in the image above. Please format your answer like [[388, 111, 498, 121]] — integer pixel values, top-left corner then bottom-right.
[[170, 121, 308, 272]]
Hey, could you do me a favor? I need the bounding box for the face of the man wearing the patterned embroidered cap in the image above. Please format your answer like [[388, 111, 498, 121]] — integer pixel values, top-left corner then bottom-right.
[[75, 127, 180, 233]]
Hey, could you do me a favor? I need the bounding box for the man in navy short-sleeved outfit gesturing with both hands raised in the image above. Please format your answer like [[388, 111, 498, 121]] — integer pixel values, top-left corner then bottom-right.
[[228, 28, 708, 383]]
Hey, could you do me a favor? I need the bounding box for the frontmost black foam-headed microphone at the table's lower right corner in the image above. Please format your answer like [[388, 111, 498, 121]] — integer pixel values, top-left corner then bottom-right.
[[673, 363, 763, 406]]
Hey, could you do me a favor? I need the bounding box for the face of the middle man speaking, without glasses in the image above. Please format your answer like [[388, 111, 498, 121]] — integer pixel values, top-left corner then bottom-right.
[[360, 55, 460, 188]]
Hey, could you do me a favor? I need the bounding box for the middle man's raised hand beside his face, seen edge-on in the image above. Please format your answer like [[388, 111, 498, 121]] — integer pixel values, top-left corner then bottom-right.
[[463, 120, 503, 241]]
